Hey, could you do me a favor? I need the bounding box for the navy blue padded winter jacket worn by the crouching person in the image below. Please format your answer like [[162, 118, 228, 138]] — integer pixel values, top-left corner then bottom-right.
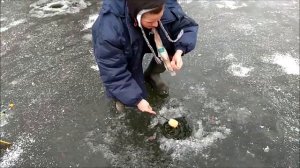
[[92, 0, 198, 106]]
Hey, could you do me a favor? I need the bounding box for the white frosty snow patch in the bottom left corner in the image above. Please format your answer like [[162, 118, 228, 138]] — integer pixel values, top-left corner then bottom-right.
[[0, 135, 35, 168]]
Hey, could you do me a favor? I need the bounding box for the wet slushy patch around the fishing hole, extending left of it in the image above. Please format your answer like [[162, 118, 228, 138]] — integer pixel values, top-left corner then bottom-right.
[[83, 99, 231, 167]]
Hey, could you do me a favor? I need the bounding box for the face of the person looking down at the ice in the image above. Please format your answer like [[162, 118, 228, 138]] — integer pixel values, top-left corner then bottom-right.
[[141, 10, 164, 29]]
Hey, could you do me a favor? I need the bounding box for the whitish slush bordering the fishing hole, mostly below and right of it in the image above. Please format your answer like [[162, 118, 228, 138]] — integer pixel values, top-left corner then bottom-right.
[[156, 98, 231, 160]]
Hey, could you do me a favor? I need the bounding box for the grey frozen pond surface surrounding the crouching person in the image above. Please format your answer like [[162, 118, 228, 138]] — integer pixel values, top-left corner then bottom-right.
[[0, 0, 299, 168]]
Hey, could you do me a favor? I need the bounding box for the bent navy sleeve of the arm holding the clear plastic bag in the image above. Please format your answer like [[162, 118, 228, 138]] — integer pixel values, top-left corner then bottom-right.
[[167, 0, 198, 54]]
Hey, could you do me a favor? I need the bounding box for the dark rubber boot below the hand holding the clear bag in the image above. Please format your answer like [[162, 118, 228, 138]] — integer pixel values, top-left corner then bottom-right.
[[144, 59, 169, 96]]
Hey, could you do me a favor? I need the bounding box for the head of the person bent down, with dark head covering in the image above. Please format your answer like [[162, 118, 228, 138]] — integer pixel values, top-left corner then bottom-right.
[[127, 0, 166, 29]]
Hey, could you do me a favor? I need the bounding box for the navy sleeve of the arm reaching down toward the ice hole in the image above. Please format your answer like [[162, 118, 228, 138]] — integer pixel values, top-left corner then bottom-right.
[[93, 17, 143, 107]]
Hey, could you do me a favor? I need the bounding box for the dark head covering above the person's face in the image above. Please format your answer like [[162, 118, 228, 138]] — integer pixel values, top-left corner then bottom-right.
[[127, 0, 166, 18]]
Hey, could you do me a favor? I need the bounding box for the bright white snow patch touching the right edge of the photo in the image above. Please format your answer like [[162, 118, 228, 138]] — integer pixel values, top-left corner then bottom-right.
[[263, 53, 299, 75]]
